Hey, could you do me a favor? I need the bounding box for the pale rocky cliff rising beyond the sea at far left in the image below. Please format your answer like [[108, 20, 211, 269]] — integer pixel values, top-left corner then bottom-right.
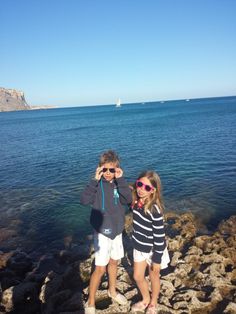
[[0, 87, 31, 111]]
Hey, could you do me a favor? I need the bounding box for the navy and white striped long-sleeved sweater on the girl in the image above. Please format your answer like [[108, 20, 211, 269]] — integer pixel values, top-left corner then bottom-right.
[[132, 205, 166, 264]]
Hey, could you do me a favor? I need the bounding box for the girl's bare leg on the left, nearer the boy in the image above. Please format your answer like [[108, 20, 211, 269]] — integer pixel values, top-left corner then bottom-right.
[[134, 261, 150, 304]]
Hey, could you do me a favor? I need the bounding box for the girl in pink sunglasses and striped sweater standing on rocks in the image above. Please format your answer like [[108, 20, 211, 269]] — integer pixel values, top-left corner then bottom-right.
[[132, 171, 170, 314]]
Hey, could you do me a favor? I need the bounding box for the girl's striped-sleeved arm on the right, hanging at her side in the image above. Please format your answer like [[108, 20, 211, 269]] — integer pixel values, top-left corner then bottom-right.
[[151, 211, 166, 264]]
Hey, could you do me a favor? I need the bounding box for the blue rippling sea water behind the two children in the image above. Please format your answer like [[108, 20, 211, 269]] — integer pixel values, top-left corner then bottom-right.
[[0, 97, 236, 251]]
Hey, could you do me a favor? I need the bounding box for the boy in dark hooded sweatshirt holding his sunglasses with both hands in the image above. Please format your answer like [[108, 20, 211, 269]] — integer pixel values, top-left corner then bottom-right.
[[80, 150, 132, 314]]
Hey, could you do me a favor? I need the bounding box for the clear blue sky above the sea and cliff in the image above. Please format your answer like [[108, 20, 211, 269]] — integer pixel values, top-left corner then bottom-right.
[[0, 0, 236, 107]]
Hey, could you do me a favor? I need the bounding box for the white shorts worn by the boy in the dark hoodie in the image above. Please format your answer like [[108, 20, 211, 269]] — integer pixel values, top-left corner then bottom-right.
[[94, 232, 124, 266]]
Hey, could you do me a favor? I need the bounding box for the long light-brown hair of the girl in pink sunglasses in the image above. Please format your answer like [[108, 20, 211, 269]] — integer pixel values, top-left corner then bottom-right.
[[132, 171, 164, 213]]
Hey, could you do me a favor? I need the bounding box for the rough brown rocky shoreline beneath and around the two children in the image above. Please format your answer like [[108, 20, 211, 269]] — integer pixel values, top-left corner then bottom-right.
[[0, 213, 236, 314]]
